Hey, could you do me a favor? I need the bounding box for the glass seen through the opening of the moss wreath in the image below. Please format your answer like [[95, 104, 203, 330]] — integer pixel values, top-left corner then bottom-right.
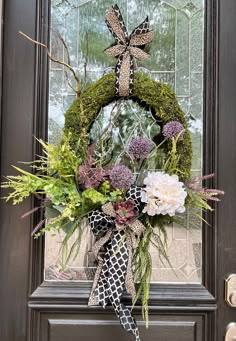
[[90, 100, 160, 168]]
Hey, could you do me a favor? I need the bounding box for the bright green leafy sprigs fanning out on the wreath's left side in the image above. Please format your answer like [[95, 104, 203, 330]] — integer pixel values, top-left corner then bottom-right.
[[1, 136, 122, 238]]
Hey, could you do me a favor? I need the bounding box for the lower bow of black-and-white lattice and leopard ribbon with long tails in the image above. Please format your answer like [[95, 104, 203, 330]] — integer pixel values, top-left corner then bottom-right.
[[88, 186, 144, 341]]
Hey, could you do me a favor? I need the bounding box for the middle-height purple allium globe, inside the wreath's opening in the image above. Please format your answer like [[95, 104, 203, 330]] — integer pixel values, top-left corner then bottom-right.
[[128, 137, 151, 160]]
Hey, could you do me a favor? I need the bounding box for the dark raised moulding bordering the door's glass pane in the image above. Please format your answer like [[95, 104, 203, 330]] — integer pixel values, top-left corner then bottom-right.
[[29, 0, 218, 305]]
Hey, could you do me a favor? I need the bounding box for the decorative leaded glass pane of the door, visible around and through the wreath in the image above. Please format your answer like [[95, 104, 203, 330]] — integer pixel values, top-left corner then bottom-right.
[[45, 0, 204, 283]]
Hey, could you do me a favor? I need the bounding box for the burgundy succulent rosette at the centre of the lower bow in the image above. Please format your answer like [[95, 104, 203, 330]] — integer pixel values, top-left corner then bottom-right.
[[114, 200, 137, 225]]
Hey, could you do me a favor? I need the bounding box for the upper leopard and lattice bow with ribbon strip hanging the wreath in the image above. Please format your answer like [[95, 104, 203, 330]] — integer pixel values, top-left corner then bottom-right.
[[104, 5, 154, 97]]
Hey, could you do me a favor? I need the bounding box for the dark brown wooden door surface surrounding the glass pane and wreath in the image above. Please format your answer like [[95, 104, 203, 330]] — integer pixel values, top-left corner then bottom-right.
[[0, 0, 236, 341]]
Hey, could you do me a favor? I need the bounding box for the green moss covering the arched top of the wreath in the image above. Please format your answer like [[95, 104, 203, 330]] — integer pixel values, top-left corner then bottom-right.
[[64, 72, 192, 180]]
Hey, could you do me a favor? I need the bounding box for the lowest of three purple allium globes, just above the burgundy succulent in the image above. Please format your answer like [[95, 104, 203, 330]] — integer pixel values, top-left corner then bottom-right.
[[109, 165, 134, 189]]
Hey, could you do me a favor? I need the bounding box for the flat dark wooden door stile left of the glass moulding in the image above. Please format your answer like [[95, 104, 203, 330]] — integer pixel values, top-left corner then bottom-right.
[[0, 1, 36, 341]]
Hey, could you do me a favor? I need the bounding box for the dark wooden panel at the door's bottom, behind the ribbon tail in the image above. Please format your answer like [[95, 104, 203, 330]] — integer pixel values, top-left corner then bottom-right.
[[40, 314, 204, 341]]
